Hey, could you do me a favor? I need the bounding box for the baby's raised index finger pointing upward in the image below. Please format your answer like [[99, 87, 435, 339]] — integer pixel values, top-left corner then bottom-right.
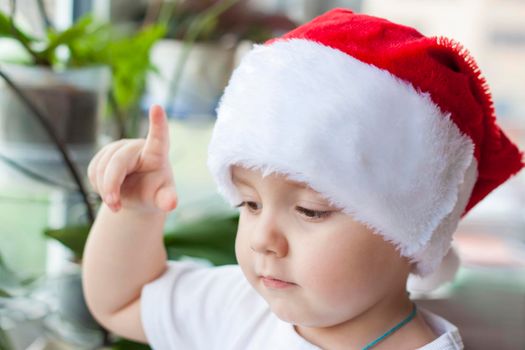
[[144, 105, 170, 158]]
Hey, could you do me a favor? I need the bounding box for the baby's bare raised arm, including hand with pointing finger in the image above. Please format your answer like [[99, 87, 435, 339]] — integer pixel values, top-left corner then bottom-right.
[[82, 107, 177, 342]]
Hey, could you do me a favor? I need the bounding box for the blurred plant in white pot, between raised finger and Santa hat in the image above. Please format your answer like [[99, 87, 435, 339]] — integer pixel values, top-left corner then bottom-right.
[[148, 0, 295, 118]]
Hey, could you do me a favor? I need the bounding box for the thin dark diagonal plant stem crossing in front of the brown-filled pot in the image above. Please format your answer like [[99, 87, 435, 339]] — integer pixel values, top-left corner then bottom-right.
[[0, 70, 95, 224]]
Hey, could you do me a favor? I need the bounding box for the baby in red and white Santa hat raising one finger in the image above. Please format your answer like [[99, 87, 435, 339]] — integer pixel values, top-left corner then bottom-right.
[[83, 9, 524, 350]]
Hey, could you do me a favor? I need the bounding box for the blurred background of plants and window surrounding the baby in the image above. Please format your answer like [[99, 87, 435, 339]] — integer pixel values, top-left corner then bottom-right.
[[0, 0, 525, 350]]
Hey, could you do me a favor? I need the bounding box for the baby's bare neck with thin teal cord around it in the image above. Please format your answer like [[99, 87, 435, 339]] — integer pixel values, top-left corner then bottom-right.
[[295, 291, 435, 350]]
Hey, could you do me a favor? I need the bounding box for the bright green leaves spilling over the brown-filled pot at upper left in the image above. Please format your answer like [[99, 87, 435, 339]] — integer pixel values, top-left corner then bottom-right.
[[0, 12, 166, 138]]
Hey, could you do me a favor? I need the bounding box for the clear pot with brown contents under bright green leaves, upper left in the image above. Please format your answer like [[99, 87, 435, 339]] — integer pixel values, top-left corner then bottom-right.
[[0, 64, 110, 145]]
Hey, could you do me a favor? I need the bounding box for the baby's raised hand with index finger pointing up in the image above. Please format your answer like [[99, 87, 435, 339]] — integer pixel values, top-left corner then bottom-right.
[[88, 106, 177, 212]]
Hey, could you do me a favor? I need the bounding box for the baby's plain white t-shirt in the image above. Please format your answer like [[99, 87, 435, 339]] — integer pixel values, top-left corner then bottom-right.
[[141, 261, 463, 350]]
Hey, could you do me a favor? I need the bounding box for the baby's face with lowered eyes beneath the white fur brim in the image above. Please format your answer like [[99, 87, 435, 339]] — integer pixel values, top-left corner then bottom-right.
[[232, 166, 409, 327]]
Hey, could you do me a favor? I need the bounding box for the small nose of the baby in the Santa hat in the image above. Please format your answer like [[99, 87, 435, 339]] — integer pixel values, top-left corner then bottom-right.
[[250, 215, 289, 258]]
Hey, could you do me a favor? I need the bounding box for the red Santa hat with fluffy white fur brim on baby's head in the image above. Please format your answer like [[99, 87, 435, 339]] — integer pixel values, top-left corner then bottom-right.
[[208, 9, 524, 284]]
